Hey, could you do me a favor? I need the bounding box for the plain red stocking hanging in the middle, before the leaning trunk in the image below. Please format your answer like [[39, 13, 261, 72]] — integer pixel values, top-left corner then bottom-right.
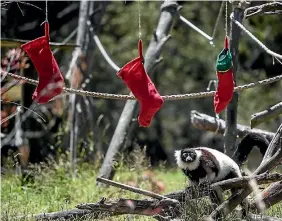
[[117, 40, 164, 127]]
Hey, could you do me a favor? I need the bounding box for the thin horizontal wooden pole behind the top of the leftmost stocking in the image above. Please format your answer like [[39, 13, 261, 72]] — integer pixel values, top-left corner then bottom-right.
[[1, 38, 80, 50]]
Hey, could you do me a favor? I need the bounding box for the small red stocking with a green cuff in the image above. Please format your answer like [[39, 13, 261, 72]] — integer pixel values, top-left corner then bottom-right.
[[214, 37, 235, 114]]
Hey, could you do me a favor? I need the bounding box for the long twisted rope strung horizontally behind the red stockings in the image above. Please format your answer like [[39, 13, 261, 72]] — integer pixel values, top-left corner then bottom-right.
[[1, 70, 282, 101]]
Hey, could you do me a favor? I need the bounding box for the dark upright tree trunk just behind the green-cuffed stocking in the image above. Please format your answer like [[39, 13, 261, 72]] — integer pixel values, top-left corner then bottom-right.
[[224, 3, 244, 156]]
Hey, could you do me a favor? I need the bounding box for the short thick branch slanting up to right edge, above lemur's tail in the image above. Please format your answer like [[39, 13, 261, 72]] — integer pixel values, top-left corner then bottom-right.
[[251, 102, 282, 128]]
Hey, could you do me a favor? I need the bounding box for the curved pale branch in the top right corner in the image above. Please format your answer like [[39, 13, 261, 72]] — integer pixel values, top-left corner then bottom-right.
[[244, 2, 282, 19]]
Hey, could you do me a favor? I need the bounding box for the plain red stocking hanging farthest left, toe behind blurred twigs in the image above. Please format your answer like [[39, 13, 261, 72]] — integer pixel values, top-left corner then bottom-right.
[[21, 22, 64, 103]]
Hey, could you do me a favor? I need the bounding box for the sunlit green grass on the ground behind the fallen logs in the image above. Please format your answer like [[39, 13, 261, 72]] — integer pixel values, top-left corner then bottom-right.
[[1, 157, 282, 220]]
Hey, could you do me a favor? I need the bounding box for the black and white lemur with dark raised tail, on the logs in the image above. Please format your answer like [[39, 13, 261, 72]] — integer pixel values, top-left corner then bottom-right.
[[175, 133, 270, 218]]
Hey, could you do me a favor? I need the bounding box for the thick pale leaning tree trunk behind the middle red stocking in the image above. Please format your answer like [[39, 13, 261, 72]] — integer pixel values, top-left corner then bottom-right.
[[99, 1, 178, 179]]
